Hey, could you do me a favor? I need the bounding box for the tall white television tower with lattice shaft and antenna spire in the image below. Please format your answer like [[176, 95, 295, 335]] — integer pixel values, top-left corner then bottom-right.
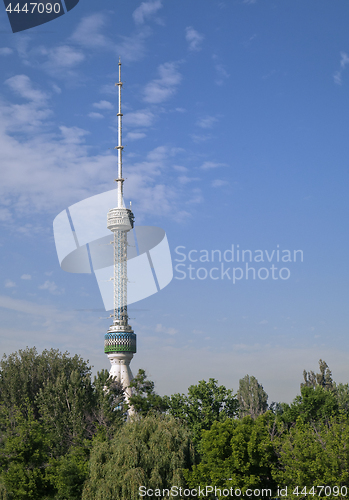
[[104, 58, 136, 401]]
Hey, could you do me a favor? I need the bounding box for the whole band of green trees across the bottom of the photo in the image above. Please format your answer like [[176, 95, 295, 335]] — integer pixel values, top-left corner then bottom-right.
[[0, 348, 349, 500]]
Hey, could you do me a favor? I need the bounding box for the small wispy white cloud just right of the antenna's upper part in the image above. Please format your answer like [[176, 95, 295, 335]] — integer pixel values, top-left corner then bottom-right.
[[144, 62, 182, 104]]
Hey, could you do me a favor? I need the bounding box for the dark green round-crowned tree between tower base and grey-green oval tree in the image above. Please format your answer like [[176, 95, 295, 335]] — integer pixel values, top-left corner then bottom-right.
[[164, 378, 238, 443]]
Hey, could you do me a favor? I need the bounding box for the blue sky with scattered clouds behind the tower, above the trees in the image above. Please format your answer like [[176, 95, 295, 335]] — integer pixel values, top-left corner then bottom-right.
[[0, 0, 349, 402]]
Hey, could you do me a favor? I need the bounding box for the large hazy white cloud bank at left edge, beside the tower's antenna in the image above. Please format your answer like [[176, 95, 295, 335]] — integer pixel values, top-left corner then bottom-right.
[[0, 93, 114, 216]]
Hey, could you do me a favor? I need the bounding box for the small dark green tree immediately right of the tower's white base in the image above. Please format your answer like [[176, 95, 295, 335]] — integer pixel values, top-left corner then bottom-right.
[[130, 369, 167, 416]]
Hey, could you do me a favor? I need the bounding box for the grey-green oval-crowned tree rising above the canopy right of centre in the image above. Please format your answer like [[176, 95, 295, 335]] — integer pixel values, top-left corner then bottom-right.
[[237, 375, 268, 418]]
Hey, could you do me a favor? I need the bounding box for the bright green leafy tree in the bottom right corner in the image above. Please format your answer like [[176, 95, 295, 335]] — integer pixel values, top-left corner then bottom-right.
[[273, 416, 349, 499]]
